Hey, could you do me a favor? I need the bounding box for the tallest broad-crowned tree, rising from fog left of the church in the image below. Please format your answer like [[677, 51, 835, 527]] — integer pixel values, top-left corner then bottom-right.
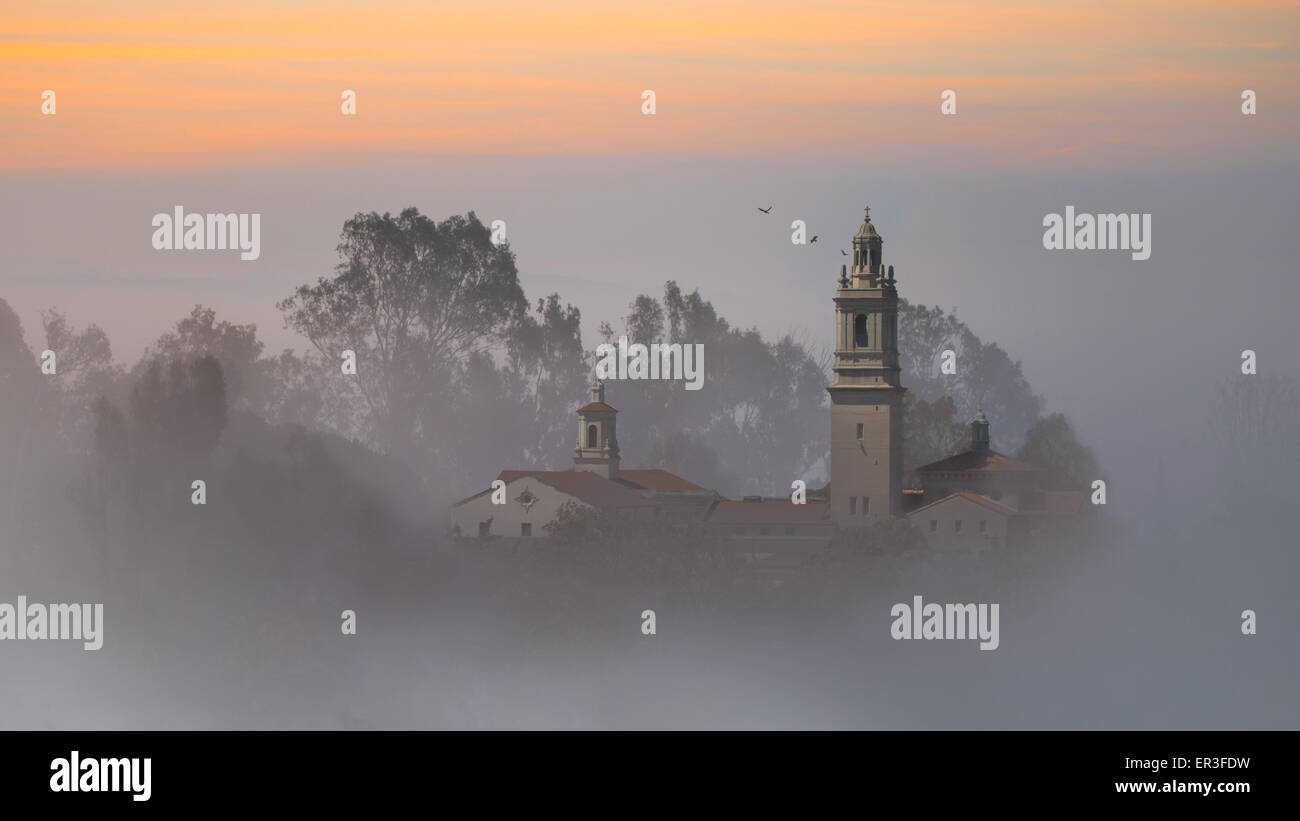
[[280, 208, 527, 453]]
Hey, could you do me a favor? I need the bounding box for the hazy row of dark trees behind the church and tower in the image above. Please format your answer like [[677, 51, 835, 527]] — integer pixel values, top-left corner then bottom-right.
[[0, 208, 1097, 545]]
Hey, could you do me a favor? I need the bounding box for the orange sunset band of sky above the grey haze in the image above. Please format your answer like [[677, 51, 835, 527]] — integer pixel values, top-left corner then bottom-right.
[[0, 0, 1300, 171]]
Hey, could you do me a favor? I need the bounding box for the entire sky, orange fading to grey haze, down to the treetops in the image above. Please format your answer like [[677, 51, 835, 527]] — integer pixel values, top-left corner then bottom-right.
[[0, 0, 1300, 519]]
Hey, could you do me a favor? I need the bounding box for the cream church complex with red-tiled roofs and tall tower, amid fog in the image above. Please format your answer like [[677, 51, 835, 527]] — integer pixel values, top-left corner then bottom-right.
[[451, 208, 1083, 555]]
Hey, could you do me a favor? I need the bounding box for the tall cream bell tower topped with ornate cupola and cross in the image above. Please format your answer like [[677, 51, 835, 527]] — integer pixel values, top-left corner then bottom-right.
[[827, 208, 906, 526]]
